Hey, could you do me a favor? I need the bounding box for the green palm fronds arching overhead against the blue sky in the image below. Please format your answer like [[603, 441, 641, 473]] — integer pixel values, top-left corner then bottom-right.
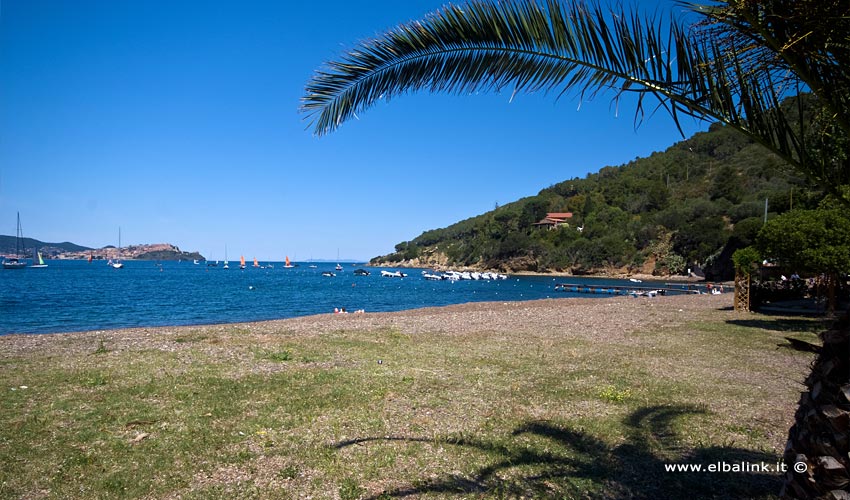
[[301, 0, 850, 203]]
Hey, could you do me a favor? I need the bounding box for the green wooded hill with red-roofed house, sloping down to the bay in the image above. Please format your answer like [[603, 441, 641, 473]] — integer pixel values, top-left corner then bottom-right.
[[372, 117, 823, 280]]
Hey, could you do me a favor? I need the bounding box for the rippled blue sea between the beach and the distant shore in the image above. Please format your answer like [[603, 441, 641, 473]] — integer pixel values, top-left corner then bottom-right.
[[0, 260, 676, 334]]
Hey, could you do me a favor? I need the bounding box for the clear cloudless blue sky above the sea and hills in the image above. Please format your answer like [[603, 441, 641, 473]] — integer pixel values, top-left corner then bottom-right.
[[0, 0, 707, 260]]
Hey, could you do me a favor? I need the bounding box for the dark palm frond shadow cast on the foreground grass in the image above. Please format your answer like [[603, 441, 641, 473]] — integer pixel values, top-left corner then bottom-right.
[[333, 406, 781, 498]]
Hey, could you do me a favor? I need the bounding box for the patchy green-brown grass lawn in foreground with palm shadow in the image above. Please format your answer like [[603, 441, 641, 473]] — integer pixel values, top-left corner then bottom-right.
[[0, 298, 820, 499]]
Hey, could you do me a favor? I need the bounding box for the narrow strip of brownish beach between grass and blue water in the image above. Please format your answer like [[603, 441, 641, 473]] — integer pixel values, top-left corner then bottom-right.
[[0, 293, 734, 357]]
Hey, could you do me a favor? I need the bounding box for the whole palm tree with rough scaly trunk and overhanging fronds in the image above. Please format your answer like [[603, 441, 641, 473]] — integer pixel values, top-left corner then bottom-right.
[[302, 0, 850, 496]]
